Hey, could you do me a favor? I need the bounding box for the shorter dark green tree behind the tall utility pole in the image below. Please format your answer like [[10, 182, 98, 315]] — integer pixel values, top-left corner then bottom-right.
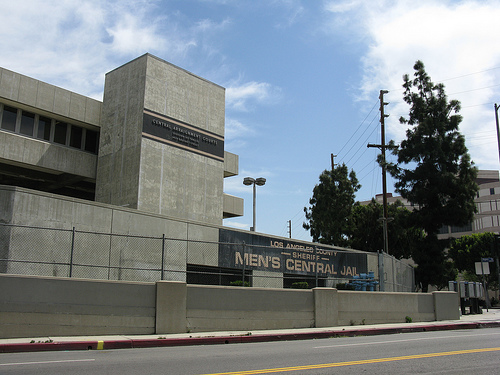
[[349, 199, 423, 259]]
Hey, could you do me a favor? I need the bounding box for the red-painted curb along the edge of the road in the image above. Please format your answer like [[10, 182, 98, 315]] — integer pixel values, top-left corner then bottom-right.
[[0, 321, 500, 353]]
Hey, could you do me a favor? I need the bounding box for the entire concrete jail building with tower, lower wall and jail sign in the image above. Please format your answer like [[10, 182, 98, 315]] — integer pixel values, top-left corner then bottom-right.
[[0, 54, 413, 291]]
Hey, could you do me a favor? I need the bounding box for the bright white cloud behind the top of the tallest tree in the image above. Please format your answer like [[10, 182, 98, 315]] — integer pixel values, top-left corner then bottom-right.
[[325, 0, 500, 169]]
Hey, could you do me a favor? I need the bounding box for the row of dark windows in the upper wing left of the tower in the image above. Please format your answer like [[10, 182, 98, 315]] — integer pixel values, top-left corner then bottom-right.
[[0, 103, 99, 154]]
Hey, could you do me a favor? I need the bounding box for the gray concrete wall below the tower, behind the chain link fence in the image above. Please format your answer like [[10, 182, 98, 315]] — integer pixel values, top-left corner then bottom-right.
[[0, 186, 224, 281]]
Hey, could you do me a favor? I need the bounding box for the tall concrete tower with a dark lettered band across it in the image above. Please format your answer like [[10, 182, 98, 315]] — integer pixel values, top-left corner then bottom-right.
[[96, 54, 225, 225]]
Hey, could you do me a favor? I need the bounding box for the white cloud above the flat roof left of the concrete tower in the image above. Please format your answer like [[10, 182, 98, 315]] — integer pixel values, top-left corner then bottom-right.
[[0, 0, 210, 99]]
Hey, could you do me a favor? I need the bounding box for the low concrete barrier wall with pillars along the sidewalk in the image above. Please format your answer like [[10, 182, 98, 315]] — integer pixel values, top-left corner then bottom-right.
[[0, 274, 460, 338]]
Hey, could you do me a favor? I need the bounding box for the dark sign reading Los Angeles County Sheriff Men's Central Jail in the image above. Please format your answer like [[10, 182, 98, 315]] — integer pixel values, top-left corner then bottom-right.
[[219, 229, 368, 278]]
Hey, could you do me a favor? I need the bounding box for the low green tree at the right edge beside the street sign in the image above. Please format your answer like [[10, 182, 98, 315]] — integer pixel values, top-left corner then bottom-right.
[[448, 233, 498, 289]]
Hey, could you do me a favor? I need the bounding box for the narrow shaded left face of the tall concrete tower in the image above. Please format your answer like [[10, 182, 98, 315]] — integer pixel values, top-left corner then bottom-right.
[[96, 56, 146, 208]]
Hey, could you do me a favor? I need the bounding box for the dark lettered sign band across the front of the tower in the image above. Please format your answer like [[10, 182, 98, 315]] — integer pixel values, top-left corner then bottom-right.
[[142, 110, 224, 161]]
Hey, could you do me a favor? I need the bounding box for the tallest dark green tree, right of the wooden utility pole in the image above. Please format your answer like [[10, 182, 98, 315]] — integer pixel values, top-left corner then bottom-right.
[[387, 61, 478, 291]]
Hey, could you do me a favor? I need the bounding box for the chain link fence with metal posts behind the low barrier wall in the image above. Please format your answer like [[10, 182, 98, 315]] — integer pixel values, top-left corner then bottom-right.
[[0, 224, 414, 292]]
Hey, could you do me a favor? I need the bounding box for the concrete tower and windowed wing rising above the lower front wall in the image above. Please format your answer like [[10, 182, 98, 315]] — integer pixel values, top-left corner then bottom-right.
[[0, 54, 243, 225]]
